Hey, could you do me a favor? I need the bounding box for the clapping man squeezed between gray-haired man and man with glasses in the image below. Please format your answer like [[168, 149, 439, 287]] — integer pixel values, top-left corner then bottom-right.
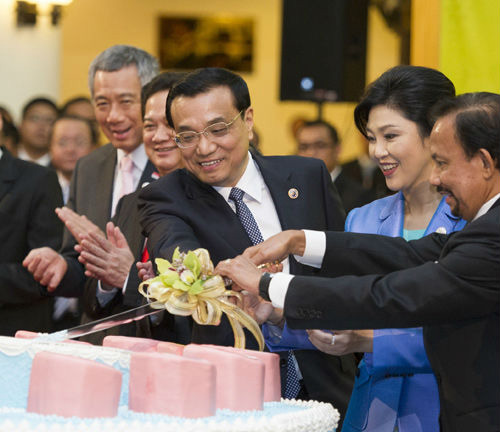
[[74, 72, 191, 343]]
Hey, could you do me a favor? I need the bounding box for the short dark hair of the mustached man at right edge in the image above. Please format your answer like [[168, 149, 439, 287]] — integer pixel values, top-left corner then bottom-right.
[[431, 92, 500, 168]]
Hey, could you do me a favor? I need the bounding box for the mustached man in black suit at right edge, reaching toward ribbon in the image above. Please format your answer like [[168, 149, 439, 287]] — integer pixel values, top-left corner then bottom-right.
[[217, 93, 500, 432]]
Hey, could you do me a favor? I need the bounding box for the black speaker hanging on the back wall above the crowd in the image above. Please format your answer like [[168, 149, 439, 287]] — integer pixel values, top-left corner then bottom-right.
[[280, 0, 368, 102]]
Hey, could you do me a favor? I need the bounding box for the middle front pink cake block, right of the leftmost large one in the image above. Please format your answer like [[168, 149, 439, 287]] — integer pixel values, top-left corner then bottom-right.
[[129, 352, 216, 418]]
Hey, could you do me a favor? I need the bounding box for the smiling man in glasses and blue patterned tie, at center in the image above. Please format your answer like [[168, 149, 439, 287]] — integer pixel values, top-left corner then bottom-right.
[[139, 68, 355, 418]]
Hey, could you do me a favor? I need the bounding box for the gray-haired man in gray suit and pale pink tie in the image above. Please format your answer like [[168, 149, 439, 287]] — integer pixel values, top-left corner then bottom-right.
[[24, 45, 159, 308]]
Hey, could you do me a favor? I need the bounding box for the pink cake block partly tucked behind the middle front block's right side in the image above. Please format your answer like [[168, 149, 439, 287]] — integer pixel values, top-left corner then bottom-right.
[[183, 344, 264, 411]]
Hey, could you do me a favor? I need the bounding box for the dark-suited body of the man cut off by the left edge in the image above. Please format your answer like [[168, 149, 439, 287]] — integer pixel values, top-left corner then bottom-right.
[[0, 135, 63, 336]]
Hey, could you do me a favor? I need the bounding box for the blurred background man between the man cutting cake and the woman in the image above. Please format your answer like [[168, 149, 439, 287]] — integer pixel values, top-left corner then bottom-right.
[[295, 120, 375, 213]]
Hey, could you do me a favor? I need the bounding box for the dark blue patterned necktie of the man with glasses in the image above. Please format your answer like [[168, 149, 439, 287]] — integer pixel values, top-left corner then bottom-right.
[[229, 187, 300, 399]]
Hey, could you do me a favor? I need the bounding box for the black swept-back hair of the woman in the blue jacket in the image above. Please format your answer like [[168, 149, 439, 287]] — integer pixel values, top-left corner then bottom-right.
[[354, 66, 455, 138]]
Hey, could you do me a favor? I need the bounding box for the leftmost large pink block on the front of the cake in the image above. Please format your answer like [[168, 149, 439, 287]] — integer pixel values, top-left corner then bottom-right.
[[26, 352, 122, 418]]
